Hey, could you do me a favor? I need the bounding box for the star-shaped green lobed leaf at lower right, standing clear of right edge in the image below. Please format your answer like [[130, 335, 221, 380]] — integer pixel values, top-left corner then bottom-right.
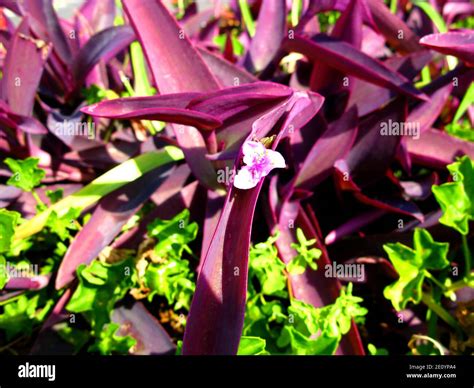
[[384, 228, 449, 311]]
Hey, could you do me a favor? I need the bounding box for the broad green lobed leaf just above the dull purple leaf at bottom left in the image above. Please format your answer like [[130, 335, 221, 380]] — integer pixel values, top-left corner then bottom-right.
[[66, 259, 136, 335]]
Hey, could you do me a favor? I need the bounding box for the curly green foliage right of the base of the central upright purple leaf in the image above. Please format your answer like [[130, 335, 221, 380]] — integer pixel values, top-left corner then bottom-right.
[[243, 234, 367, 354]]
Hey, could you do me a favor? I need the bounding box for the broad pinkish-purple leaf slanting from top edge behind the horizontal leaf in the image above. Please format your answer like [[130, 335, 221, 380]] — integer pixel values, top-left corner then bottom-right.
[[123, 0, 220, 188]]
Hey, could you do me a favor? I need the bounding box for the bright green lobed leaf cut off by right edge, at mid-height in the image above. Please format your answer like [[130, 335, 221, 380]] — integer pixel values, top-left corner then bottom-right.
[[433, 156, 474, 235]]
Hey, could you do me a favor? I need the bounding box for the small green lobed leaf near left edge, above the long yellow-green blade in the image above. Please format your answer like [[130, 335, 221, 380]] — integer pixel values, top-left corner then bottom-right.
[[5, 157, 46, 191]]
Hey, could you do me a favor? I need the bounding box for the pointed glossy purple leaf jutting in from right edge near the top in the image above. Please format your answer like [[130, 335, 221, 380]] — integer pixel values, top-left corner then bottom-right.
[[420, 30, 474, 66]]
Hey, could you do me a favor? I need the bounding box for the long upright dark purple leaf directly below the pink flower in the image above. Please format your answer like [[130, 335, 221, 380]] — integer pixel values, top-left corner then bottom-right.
[[183, 91, 322, 354]]
